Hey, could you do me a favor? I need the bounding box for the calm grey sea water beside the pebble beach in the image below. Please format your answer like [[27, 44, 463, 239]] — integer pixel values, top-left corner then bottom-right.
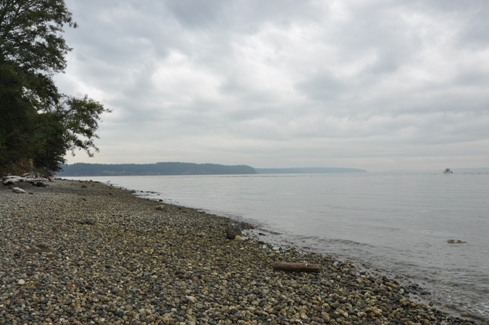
[[66, 173, 489, 319]]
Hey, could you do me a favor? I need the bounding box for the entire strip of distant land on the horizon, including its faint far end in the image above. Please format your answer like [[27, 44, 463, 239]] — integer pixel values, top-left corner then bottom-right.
[[56, 162, 367, 177]]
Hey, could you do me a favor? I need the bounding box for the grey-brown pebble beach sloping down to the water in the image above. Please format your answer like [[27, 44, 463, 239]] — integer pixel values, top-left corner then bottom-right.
[[0, 180, 477, 325]]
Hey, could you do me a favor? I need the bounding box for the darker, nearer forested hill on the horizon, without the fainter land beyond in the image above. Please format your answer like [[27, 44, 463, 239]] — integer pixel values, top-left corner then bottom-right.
[[56, 162, 256, 177]]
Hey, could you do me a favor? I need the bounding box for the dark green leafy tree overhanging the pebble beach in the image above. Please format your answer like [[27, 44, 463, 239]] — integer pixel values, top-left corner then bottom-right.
[[0, 0, 109, 173]]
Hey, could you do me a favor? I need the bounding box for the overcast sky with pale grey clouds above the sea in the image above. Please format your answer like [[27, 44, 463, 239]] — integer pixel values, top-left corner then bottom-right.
[[56, 0, 489, 171]]
